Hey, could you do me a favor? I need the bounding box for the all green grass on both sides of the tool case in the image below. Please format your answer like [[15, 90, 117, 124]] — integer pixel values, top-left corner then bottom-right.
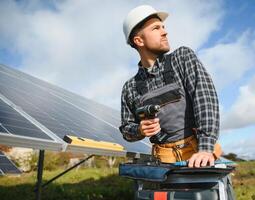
[[0, 161, 255, 200]]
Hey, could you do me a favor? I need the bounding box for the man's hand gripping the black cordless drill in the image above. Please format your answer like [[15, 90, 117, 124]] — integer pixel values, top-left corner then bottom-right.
[[139, 118, 161, 137]]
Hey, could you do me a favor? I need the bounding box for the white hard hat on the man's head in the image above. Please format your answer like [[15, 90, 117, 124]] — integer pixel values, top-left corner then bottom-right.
[[123, 5, 168, 44]]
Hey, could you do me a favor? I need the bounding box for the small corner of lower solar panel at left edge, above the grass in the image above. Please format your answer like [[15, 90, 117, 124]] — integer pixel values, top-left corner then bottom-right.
[[0, 154, 21, 174]]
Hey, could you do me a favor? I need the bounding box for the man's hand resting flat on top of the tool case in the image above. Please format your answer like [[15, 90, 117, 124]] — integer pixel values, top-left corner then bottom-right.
[[188, 151, 215, 167]]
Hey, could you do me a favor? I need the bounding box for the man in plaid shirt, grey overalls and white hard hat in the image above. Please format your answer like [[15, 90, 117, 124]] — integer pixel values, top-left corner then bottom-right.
[[120, 5, 220, 167]]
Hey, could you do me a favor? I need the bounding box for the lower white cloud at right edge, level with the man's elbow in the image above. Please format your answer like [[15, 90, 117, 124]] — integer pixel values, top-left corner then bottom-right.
[[222, 76, 255, 129]]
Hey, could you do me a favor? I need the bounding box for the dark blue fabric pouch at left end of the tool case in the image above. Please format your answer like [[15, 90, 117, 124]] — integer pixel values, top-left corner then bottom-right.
[[119, 163, 170, 182]]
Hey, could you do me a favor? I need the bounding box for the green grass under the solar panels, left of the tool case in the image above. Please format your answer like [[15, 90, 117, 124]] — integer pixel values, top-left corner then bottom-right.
[[0, 168, 133, 200]]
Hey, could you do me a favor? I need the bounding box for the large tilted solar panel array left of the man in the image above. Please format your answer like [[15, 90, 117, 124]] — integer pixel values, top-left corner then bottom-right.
[[0, 65, 150, 154]]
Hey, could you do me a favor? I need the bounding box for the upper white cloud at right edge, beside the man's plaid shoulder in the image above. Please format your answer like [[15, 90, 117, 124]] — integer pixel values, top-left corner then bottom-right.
[[199, 30, 255, 90]]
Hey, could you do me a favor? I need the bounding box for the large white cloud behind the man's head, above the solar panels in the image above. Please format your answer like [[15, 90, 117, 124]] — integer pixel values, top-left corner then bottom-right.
[[0, 0, 222, 108]]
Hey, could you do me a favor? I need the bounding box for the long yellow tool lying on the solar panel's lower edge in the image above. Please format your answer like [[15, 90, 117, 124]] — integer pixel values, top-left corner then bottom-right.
[[63, 135, 124, 151]]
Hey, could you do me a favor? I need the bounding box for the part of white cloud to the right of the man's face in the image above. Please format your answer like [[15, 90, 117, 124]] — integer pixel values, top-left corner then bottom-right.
[[167, 0, 224, 50]]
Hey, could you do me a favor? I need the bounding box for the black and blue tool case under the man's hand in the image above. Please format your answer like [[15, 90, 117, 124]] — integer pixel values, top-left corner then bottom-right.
[[119, 162, 235, 200]]
